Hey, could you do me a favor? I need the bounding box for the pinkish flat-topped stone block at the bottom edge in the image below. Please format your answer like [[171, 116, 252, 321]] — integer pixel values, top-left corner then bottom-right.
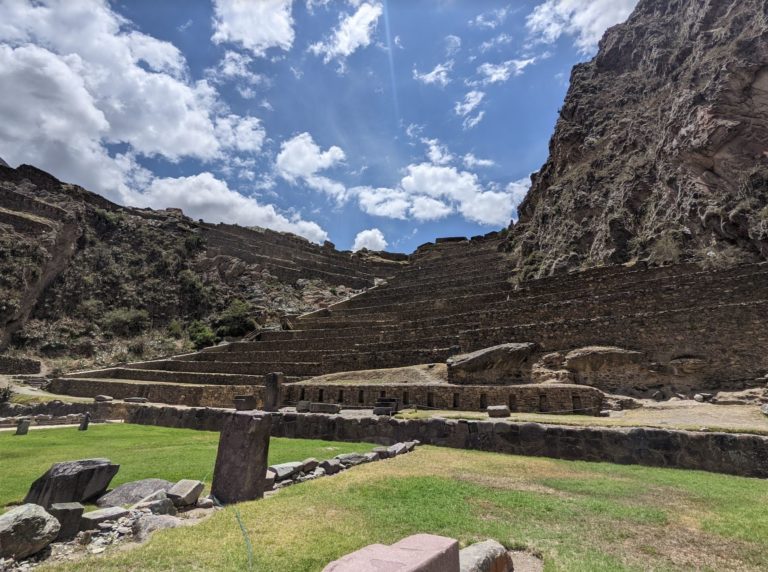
[[323, 534, 459, 572]]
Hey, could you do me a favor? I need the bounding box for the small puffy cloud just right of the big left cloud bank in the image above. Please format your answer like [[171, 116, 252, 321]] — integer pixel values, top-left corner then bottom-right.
[[275, 133, 347, 203]]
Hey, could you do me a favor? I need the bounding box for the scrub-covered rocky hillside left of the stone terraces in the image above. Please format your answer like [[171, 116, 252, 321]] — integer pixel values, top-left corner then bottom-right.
[[0, 165, 396, 365]]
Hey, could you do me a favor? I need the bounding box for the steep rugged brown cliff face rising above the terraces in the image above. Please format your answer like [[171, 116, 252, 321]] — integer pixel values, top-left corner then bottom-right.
[[506, 0, 768, 277]]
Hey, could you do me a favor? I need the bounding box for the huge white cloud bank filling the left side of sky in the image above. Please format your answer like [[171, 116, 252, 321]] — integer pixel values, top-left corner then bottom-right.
[[0, 0, 326, 240]]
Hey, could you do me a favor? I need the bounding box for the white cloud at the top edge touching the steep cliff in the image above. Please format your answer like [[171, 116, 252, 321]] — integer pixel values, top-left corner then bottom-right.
[[526, 0, 638, 54]]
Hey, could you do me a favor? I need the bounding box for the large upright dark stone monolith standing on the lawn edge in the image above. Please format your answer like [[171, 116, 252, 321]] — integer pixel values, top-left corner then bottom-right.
[[211, 411, 272, 504]]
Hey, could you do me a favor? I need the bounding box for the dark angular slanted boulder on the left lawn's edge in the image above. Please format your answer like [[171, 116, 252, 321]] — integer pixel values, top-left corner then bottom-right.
[[24, 459, 120, 507]]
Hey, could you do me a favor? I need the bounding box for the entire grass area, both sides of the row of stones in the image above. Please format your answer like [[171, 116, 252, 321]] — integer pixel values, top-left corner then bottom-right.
[[0, 426, 768, 572]]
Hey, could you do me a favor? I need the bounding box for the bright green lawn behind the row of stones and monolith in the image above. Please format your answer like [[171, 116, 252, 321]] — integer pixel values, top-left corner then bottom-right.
[[0, 424, 374, 512]]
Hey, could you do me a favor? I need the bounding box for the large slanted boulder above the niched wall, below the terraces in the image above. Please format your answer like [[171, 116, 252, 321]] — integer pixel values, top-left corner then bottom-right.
[[447, 342, 538, 385]]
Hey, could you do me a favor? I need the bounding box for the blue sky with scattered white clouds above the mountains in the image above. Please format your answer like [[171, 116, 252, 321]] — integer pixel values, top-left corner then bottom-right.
[[0, 0, 636, 252]]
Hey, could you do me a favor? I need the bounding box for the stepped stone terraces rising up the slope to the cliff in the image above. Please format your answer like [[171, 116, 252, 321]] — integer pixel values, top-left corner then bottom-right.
[[54, 236, 768, 411]]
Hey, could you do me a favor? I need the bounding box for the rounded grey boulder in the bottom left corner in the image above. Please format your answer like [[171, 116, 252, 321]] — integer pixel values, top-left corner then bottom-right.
[[0, 504, 61, 560]]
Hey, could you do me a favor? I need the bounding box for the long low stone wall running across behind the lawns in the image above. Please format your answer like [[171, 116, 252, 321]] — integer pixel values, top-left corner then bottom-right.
[[0, 402, 768, 478]]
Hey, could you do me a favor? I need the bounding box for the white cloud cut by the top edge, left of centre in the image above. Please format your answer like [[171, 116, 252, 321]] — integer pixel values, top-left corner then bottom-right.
[[211, 0, 294, 57]]
